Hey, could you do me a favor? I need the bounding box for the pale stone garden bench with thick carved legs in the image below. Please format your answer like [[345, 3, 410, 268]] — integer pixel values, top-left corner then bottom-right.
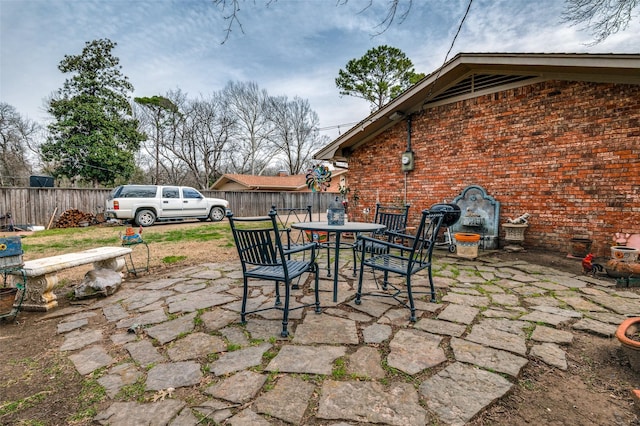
[[12, 247, 131, 311]]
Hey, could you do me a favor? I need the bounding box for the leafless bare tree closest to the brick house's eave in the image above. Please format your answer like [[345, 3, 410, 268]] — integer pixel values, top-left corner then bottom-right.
[[270, 96, 326, 175]]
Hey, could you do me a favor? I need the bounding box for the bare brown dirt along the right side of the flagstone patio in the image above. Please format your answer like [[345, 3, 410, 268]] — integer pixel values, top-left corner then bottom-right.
[[470, 251, 640, 426]]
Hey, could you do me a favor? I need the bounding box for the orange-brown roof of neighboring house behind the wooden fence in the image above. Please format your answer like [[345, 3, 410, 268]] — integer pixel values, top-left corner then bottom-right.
[[211, 169, 347, 192]]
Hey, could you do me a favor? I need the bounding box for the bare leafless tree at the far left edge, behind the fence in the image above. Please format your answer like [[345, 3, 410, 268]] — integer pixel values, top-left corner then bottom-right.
[[0, 102, 40, 186]]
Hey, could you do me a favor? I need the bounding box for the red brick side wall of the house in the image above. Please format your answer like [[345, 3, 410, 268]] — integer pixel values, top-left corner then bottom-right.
[[348, 81, 640, 256]]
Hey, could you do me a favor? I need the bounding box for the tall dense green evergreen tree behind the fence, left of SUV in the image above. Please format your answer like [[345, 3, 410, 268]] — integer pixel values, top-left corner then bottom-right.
[[41, 39, 145, 187]]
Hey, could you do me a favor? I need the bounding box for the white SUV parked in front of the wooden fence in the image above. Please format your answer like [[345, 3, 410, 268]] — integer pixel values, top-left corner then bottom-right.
[[105, 185, 229, 226]]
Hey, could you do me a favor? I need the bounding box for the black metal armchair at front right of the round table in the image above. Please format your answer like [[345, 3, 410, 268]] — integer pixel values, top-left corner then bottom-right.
[[355, 210, 445, 322]]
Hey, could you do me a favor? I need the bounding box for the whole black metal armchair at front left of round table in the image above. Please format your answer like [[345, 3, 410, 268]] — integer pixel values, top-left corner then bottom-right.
[[227, 211, 321, 337]]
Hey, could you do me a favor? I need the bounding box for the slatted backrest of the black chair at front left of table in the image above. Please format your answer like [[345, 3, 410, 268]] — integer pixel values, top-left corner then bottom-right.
[[227, 211, 285, 271]]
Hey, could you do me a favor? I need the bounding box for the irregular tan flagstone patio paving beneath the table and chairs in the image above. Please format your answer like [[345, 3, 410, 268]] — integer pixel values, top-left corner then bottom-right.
[[42, 253, 640, 426]]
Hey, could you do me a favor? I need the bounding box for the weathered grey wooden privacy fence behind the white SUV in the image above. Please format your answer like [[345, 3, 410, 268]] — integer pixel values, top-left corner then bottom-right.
[[0, 188, 336, 227]]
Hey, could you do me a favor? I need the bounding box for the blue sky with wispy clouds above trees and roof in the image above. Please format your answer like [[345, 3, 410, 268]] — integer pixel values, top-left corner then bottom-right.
[[0, 0, 640, 138]]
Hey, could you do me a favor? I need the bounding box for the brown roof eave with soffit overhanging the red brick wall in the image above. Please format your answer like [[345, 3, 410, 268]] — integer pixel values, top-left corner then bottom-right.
[[314, 53, 640, 161]]
